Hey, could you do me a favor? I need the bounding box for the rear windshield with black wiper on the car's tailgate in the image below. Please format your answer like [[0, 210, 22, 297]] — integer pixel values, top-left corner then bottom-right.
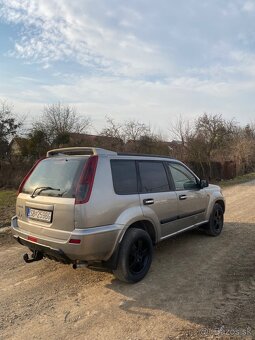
[[22, 157, 87, 198]]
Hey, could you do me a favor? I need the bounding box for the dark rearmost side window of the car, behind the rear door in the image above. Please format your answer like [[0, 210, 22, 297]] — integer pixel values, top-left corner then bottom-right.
[[111, 160, 138, 195]]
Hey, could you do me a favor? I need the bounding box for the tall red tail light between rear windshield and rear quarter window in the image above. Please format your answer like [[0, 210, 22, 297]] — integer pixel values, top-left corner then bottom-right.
[[75, 156, 98, 204]]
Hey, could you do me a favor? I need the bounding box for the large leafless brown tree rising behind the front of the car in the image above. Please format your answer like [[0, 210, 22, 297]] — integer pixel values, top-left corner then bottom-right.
[[170, 113, 240, 177]]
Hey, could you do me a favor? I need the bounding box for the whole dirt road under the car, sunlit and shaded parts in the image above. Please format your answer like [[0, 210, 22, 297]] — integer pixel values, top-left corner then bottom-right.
[[0, 182, 255, 339]]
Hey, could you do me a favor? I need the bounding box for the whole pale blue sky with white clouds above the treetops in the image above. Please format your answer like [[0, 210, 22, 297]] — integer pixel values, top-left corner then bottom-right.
[[0, 0, 255, 134]]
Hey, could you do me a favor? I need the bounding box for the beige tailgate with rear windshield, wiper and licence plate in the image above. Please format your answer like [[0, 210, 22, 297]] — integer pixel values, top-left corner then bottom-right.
[[17, 157, 86, 236]]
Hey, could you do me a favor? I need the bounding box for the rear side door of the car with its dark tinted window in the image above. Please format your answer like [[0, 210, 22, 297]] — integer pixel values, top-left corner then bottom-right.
[[137, 160, 178, 238]]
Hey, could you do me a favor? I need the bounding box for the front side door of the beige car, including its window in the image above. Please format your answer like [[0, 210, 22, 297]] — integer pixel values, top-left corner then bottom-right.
[[167, 162, 209, 230]]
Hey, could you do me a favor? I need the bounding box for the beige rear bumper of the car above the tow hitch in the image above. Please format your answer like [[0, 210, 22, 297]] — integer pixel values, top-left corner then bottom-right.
[[11, 216, 123, 263]]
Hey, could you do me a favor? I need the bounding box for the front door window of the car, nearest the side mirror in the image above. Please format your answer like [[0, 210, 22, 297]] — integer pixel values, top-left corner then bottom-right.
[[168, 163, 198, 190]]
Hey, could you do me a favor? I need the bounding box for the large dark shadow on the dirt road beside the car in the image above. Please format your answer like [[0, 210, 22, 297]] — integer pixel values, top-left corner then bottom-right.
[[104, 223, 255, 329]]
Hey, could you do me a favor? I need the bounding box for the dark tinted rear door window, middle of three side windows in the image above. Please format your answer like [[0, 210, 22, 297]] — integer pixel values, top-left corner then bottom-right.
[[138, 161, 170, 193]]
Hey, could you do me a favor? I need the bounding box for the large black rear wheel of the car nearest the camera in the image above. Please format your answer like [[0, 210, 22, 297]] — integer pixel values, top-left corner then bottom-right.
[[113, 228, 153, 283]]
